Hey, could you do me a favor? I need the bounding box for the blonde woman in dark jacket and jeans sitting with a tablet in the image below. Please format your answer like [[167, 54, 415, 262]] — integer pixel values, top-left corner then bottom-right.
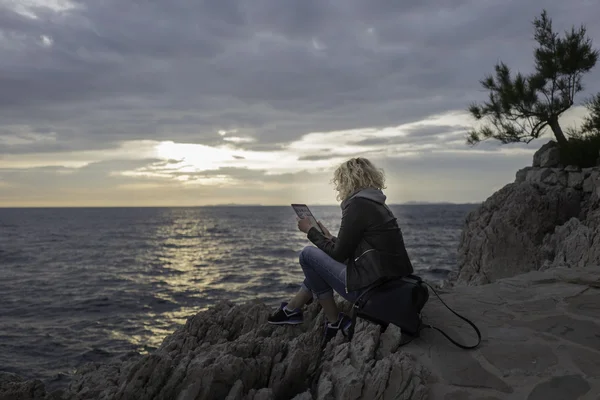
[[268, 158, 413, 341]]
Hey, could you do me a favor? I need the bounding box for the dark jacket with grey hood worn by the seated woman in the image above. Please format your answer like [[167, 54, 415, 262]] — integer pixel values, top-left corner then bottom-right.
[[308, 189, 413, 292]]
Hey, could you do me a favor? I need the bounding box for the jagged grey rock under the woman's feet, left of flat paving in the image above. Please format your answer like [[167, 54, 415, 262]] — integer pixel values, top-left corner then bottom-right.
[[5, 302, 427, 400]]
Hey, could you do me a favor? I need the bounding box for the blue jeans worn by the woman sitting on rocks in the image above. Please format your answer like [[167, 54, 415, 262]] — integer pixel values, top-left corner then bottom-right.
[[300, 246, 360, 302]]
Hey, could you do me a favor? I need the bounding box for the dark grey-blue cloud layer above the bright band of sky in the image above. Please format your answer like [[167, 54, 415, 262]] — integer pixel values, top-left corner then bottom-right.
[[0, 0, 600, 153]]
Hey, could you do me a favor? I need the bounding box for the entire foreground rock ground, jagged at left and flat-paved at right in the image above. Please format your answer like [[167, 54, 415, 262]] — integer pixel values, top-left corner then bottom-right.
[[0, 266, 600, 400]]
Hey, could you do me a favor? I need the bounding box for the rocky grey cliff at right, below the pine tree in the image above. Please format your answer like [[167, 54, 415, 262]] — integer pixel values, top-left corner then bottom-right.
[[458, 142, 600, 285]]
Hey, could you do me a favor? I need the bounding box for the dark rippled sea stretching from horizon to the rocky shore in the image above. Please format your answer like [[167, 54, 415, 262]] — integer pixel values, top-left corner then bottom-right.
[[0, 205, 474, 385]]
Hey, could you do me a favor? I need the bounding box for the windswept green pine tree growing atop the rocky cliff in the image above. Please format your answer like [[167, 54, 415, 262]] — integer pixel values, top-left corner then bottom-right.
[[467, 10, 600, 146]]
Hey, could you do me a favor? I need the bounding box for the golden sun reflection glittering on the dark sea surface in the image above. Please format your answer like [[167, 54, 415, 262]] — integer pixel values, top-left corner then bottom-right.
[[116, 209, 301, 352]]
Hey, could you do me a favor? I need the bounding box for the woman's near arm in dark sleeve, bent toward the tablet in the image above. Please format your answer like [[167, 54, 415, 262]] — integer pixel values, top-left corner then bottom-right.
[[308, 199, 365, 262]]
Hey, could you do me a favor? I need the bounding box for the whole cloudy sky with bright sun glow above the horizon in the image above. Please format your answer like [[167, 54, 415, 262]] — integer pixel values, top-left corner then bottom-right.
[[0, 0, 600, 206]]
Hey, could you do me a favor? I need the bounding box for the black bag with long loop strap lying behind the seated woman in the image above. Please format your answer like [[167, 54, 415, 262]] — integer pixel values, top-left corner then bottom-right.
[[348, 275, 481, 349]]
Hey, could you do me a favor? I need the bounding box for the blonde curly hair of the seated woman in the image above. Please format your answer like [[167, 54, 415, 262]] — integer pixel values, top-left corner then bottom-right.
[[332, 157, 385, 201]]
